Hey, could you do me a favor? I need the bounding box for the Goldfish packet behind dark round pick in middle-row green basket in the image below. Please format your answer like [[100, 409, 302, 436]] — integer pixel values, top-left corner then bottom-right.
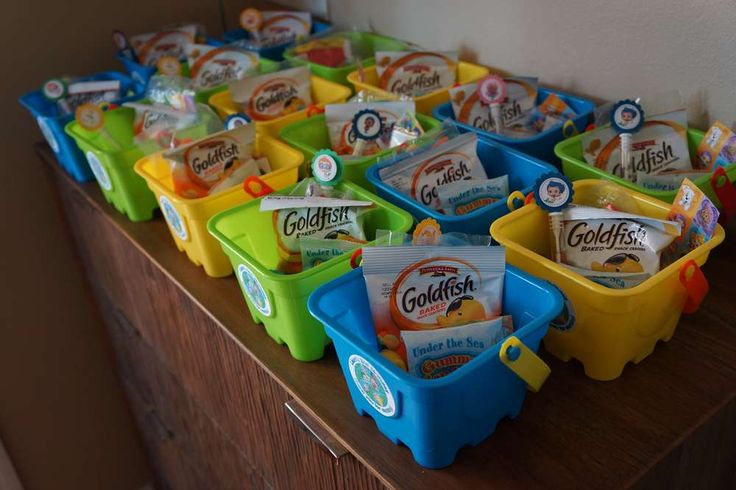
[[325, 101, 416, 156]]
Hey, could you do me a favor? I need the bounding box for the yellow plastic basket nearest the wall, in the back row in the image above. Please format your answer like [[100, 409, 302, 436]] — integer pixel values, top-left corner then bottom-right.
[[348, 61, 494, 116]]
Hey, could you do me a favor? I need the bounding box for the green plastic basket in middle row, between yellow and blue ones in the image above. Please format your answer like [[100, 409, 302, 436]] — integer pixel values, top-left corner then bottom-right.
[[279, 114, 441, 191]]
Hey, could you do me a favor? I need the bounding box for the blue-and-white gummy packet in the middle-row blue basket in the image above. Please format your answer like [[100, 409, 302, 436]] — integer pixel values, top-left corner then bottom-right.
[[437, 175, 509, 216]]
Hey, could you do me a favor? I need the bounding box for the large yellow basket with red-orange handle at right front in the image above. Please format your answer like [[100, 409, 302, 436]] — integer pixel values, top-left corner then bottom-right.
[[491, 179, 725, 381]]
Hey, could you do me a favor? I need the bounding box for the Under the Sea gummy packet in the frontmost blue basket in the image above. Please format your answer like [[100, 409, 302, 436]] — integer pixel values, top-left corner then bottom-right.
[[401, 316, 514, 379]]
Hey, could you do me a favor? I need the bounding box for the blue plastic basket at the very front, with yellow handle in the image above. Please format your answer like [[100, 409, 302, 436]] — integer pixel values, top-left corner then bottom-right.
[[308, 266, 563, 468]]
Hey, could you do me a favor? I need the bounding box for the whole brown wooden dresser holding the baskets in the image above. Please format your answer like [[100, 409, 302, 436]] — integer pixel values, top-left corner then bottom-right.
[[43, 145, 736, 489]]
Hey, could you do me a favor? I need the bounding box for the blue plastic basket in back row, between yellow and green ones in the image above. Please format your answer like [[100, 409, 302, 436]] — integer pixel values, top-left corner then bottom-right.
[[432, 87, 595, 168]]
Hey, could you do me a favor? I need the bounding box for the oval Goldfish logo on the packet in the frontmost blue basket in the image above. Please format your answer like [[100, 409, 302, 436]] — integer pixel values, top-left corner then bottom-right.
[[389, 257, 486, 330]]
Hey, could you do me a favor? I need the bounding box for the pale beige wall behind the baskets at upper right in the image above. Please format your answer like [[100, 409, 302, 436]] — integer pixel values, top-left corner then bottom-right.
[[330, 0, 736, 126]]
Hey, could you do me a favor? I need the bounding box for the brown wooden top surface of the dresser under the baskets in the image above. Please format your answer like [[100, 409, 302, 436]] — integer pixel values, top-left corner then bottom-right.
[[38, 144, 736, 488]]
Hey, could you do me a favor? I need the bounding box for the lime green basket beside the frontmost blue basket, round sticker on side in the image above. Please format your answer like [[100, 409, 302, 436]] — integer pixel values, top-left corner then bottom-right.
[[207, 182, 413, 361]]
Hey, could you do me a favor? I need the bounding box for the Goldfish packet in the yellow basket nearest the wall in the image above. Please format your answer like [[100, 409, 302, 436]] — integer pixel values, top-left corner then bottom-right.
[[375, 51, 457, 96]]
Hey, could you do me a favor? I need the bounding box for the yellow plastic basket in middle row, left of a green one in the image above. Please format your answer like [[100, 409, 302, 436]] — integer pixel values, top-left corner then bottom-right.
[[210, 75, 350, 138]]
